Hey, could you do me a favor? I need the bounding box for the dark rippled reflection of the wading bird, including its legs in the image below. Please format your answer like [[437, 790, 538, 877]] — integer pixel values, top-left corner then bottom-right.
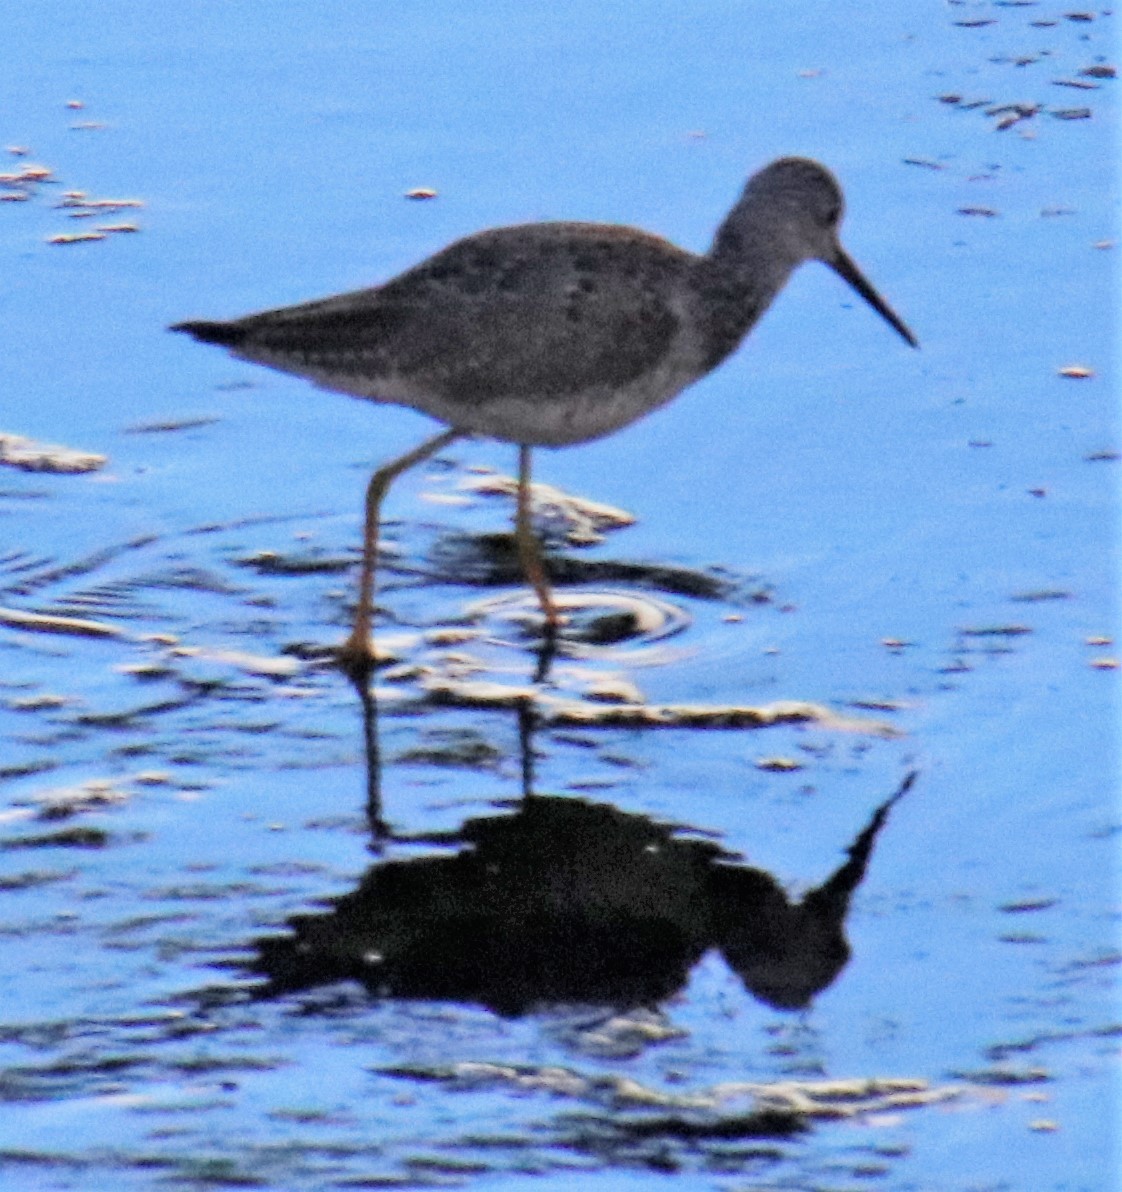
[[249, 688, 915, 1016]]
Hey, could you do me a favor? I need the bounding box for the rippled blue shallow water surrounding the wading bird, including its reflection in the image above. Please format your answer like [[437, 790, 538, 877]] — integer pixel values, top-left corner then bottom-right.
[[0, 0, 1122, 1192]]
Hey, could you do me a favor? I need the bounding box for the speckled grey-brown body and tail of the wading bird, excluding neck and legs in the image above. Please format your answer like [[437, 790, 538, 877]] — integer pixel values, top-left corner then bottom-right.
[[175, 223, 707, 443]]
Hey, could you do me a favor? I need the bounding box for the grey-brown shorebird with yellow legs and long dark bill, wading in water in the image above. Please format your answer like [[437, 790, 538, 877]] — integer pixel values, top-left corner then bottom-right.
[[172, 157, 918, 678]]
